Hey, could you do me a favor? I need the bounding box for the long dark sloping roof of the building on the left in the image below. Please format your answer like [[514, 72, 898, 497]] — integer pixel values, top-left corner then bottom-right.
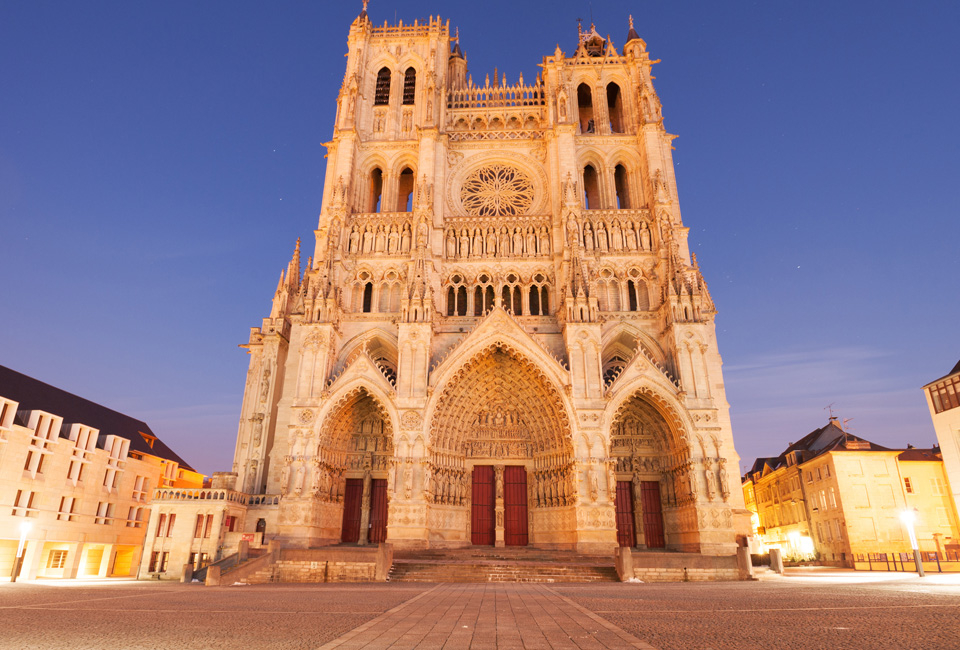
[[0, 366, 196, 471]]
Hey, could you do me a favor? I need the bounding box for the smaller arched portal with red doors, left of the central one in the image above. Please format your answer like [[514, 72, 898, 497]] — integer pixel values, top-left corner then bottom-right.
[[314, 388, 393, 544]]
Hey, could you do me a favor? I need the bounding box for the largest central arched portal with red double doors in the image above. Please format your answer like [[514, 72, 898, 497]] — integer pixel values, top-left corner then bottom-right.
[[427, 344, 576, 546]]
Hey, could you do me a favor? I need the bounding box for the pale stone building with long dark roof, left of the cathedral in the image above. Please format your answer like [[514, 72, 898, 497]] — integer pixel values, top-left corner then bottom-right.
[[0, 366, 203, 579]]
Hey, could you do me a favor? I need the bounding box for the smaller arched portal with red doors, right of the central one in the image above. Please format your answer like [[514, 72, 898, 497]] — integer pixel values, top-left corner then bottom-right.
[[610, 392, 696, 549]]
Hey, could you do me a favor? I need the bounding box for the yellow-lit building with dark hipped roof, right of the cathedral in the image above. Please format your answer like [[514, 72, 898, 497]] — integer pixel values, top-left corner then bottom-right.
[[743, 418, 960, 566]]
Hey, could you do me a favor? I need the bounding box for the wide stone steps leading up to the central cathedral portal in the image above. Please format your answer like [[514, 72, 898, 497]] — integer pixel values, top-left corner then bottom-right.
[[389, 548, 618, 583]]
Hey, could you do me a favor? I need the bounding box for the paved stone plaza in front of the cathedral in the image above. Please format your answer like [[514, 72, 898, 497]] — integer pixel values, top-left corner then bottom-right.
[[0, 570, 960, 650]]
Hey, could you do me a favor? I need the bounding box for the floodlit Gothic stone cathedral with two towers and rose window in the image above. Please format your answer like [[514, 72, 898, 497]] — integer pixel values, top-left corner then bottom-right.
[[161, 3, 749, 556]]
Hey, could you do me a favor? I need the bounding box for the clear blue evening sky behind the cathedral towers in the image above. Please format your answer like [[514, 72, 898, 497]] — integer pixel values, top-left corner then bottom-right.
[[0, 0, 960, 473]]
